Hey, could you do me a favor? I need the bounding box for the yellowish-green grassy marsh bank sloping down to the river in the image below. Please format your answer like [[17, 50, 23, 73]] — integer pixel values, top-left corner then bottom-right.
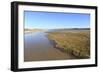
[[47, 30, 90, 58]]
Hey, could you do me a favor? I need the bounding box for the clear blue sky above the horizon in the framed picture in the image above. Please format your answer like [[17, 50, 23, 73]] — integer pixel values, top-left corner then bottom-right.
[[24, 11, 90, 29]]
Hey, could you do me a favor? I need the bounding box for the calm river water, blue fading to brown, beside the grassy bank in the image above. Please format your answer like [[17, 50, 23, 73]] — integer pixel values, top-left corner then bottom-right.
[[24, 32, 74, 61]]
